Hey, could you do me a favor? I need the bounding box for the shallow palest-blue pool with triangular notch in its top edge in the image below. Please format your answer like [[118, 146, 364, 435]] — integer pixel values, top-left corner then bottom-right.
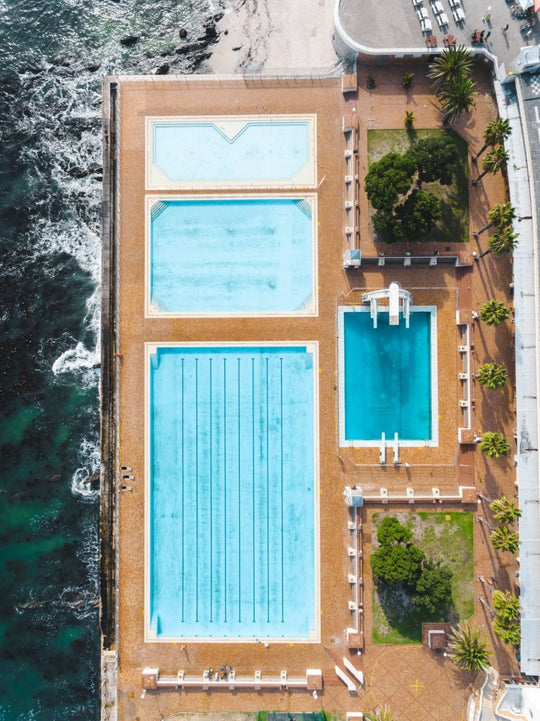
[[146, 115, 316, 189]]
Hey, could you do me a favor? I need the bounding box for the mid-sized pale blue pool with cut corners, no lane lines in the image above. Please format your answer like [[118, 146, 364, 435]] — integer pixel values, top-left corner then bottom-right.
[[147, 196, 316, 315]]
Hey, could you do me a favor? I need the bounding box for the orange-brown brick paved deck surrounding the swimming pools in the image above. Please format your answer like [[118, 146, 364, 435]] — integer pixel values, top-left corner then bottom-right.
[[103, 65, 518, 721]]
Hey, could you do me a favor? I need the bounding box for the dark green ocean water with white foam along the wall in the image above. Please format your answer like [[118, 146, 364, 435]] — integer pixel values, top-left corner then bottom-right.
[[0, 0, 219, 721]]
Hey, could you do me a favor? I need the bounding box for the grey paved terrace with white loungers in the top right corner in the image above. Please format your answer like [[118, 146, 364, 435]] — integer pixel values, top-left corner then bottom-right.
[[338, 0, 540, 70]]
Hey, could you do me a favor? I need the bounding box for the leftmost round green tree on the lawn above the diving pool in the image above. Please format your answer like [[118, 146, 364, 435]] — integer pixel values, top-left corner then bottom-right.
[[365, 152, 416, 210]]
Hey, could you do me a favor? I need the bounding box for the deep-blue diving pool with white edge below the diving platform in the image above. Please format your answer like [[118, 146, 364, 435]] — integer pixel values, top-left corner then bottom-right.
[[338, 306, 438, 447]]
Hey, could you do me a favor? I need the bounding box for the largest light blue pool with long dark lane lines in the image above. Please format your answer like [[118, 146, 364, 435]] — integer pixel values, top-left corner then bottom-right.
[[147, 345, 318, 640]]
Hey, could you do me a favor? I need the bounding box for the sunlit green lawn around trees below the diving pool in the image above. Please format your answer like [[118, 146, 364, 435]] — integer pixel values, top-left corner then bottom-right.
[[372, 512, 474, 643]]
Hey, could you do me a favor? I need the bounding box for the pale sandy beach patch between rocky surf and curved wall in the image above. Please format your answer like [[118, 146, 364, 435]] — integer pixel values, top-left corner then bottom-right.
[[208, 0, 338, 74]]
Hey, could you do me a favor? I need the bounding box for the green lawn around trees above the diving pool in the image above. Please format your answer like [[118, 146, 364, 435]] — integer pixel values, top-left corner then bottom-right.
[[368, 129, 469, 243]]
